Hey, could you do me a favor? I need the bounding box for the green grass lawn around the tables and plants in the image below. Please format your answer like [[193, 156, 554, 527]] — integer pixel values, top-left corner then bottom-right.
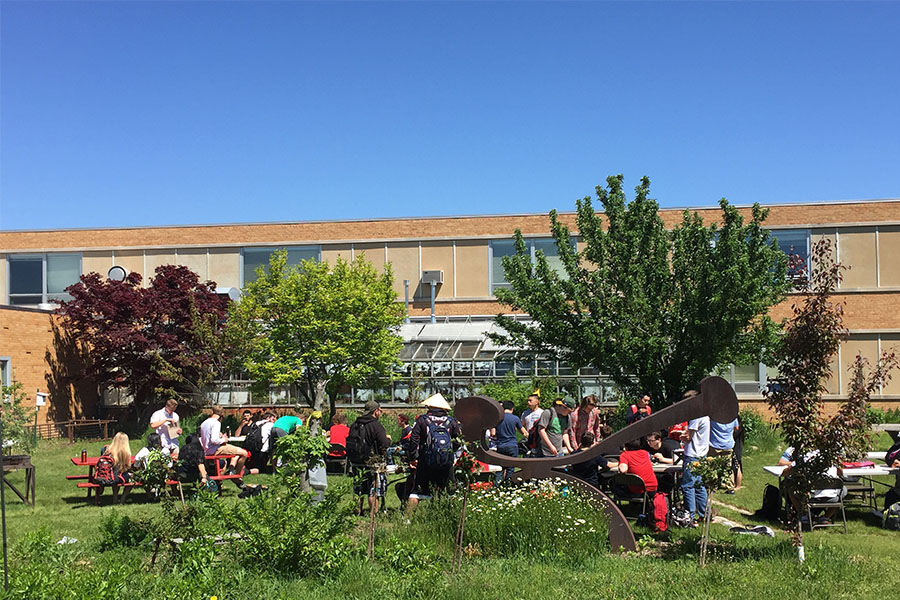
[[2, 436, 900, 600]]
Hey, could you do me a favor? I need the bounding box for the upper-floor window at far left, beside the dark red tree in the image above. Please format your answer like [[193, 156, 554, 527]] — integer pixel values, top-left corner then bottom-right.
[[8, 254, 81, 306]]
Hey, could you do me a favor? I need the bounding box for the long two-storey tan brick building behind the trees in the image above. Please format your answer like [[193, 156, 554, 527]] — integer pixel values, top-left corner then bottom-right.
[[0, 200, 900, 416]]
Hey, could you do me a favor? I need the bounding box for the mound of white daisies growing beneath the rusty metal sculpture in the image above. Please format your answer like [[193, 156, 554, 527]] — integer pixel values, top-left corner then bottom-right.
[[417, 479, 609, 561]]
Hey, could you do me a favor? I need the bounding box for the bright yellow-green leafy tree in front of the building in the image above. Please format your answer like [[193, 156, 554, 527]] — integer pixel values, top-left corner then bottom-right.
[[229, 250, 404, 427]]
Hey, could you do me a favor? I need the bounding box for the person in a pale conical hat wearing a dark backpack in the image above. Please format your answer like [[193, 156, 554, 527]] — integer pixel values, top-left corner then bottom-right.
[[407, 394, 460, 516]]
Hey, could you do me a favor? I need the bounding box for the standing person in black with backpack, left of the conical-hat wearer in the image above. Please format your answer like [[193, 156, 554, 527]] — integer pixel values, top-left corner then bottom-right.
[[347, 400, 391, 512]]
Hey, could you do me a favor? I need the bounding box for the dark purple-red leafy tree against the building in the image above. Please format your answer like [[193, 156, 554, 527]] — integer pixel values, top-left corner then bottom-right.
[[57, 265, 230, 407]]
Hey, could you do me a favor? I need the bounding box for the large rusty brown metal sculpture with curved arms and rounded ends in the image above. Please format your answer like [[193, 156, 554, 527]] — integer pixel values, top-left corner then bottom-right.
[[454, 377, 738, 551]]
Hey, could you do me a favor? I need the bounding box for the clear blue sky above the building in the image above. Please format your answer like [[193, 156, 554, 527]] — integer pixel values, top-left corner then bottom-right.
[[0, 0, 900, 229]]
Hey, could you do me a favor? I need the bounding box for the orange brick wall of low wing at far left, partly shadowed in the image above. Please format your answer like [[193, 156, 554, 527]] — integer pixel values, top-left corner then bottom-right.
[[0, 307, 97, 423]]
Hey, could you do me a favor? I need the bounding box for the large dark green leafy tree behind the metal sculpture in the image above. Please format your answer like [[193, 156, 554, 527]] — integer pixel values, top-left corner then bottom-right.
[[496, 175, 791, 404]]
